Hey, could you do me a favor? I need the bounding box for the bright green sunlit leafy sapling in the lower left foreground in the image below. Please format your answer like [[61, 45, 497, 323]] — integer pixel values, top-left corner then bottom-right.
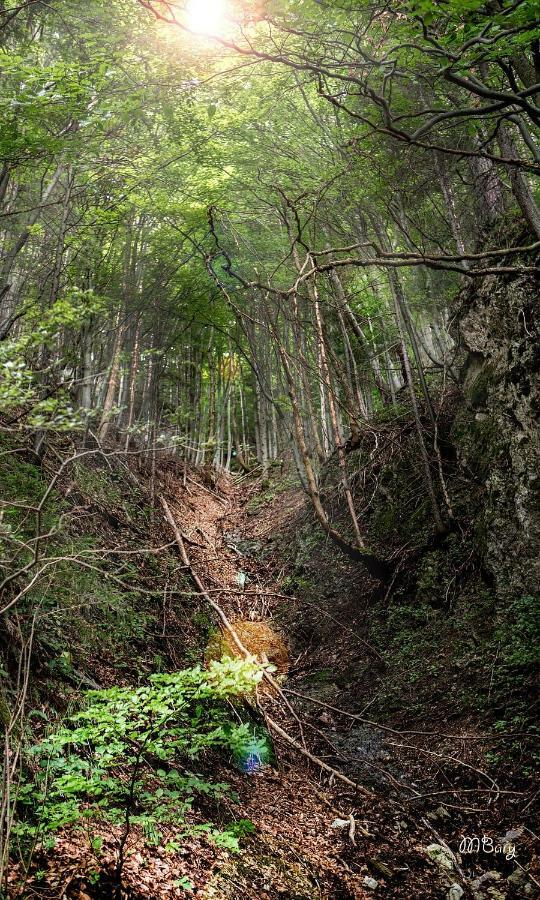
[[15, 659, 262, 849]]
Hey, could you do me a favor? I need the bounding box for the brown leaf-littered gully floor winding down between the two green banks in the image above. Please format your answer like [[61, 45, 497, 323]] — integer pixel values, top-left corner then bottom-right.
[[5, 458, 539, 900]]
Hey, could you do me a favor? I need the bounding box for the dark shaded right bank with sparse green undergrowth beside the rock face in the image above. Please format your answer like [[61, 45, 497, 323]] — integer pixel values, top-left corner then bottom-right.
[[270, 419, 540, 754]]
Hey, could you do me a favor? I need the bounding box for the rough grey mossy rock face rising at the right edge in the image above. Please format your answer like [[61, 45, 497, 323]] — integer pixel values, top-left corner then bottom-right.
[[454, 261, 540, 600]]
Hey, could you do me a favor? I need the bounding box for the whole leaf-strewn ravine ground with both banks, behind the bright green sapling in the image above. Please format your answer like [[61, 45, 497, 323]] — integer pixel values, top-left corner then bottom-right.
[[4, 406, 537, 900]]
